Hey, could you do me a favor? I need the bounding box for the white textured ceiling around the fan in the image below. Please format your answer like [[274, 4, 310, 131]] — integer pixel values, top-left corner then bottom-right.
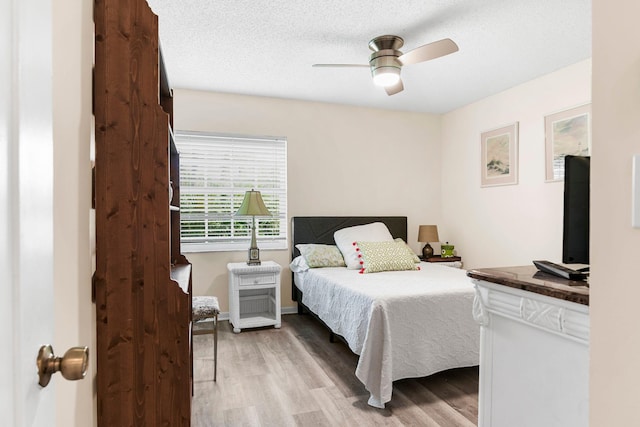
[[148, 0, 591, 113]]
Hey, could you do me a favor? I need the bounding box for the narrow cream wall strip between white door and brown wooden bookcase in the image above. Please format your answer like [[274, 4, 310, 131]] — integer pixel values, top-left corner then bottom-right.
[[52, 0, 95, 426]]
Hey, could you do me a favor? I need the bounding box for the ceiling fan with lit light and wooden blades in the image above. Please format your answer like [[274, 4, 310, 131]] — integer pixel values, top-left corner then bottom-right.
[[313, 35, 458, 95]]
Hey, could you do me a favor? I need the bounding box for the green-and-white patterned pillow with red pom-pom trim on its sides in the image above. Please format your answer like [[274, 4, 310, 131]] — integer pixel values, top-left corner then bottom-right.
[[357, 241, 420, 273]]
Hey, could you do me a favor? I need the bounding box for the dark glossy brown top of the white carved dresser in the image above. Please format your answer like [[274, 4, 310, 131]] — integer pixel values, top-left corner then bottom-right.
[[467, 265, 589, 305]]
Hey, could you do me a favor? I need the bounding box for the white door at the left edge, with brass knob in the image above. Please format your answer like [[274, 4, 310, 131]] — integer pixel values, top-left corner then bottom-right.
[[0, 0, 59, 427]]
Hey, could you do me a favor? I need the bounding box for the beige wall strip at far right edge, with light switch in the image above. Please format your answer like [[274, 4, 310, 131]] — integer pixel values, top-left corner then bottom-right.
[[590, 0, 640, 427]]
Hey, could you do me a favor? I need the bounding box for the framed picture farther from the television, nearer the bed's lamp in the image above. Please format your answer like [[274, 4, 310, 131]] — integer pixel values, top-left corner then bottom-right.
[[480, 122, 518, 187]]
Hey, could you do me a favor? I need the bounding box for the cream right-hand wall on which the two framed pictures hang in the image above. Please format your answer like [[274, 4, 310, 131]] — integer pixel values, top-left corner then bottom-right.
[[441, 60, 591, 268]]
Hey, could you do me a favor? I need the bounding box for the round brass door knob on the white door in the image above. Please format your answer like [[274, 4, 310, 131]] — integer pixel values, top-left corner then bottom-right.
[[36, 345, 89, 387]]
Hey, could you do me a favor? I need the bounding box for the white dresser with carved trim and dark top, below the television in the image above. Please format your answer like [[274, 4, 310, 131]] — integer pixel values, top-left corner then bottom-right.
[[468, 266, 589, 427]]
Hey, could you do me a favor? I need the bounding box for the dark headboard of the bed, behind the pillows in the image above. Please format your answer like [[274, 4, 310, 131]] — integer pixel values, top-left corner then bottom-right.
[[291, 216, 407, 259]]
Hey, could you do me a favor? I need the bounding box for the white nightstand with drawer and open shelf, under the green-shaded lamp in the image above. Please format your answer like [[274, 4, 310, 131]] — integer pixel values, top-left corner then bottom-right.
[[227, 261, 282, 333]]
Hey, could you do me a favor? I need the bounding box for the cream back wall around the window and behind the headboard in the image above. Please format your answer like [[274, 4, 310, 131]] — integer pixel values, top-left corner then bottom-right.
[[174, 90, 446, 312]]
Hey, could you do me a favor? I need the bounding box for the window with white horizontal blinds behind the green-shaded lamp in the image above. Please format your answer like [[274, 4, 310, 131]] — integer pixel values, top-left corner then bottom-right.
[[175, 131, 287, 252]]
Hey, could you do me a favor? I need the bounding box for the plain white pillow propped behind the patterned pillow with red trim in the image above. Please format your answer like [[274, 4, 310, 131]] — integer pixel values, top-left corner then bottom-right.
[[333, 222, 393, 270]]
